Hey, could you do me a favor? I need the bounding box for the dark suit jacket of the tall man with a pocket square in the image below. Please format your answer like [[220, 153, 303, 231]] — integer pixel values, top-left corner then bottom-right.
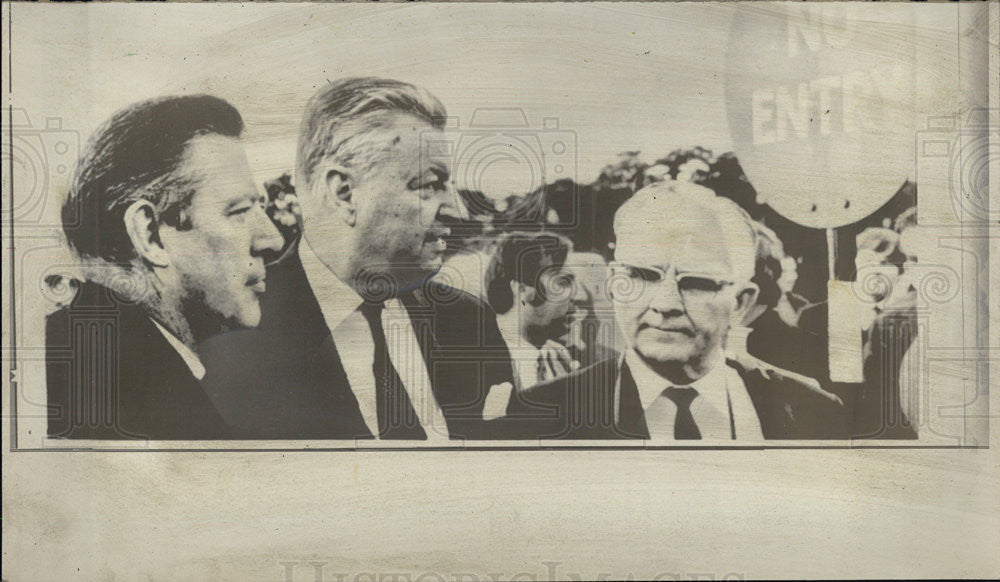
[[199, 253, 513, 439]]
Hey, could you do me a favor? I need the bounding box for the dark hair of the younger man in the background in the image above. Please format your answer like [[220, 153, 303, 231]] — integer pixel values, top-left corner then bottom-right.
[[486, 232, 573, 314]]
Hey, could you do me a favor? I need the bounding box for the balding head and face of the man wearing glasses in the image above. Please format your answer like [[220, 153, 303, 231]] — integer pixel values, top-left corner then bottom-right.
[[609, 182, 756, 384]]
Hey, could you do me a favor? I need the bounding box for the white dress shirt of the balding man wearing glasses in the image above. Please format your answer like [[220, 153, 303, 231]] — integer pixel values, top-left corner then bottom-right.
[[615, 350, 764, 441]]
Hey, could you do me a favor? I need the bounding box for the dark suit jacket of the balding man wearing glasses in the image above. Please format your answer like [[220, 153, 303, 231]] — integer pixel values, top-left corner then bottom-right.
[[504, 358, 843, 439]]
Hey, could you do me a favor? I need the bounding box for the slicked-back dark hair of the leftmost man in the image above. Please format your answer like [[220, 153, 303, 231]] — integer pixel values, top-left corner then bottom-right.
[[62, 95, 243, 263]]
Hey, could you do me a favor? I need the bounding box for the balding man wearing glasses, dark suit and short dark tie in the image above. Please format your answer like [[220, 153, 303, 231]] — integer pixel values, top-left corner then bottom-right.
[[508, 182, 842, 443]]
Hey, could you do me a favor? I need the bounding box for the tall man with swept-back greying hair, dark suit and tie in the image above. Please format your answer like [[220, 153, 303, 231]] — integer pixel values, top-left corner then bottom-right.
[[205, 78, 513, 441]]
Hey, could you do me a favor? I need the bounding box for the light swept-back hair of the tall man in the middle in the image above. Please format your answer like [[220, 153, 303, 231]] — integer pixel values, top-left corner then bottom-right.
[[295, 77, 447, 190]]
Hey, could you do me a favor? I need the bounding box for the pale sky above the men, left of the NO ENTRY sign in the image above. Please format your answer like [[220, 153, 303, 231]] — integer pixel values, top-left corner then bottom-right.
[[12, 4, 732, 189]]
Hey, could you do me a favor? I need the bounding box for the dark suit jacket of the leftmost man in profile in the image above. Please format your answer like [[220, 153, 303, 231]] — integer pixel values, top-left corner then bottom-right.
[[45, 283, 227, 440]]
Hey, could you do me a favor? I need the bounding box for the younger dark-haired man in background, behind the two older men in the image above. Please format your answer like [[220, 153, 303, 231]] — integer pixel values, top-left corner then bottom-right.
[[486, 232, 580, 390]]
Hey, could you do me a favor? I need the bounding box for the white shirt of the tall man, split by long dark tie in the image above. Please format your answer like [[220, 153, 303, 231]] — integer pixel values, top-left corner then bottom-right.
[[299, 239, 448, 441]]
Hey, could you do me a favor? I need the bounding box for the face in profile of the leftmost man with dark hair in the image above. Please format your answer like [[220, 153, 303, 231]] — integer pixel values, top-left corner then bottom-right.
[[159, 135, 283, 334]]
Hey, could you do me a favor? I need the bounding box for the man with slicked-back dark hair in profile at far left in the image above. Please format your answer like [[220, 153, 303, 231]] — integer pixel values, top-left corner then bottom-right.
[[46, 95, 282, 439]]
